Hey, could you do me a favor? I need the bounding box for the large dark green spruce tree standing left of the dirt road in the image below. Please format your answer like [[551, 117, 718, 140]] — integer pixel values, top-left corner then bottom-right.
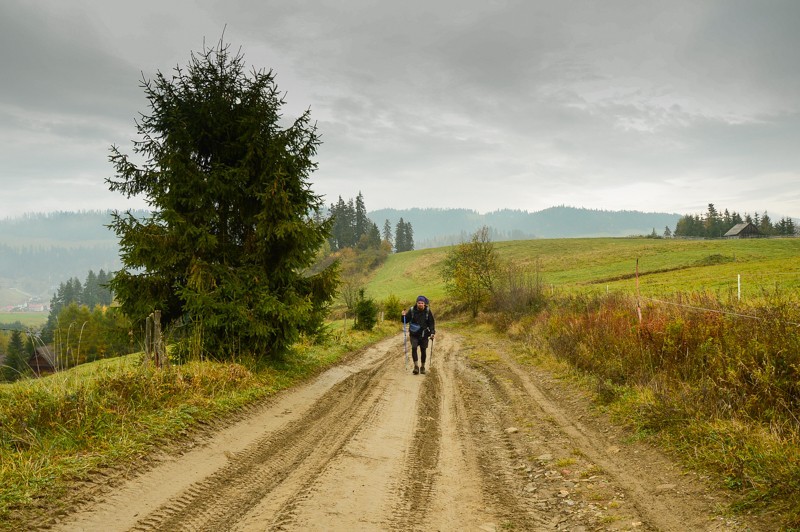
[[108, 41, 338, 358]]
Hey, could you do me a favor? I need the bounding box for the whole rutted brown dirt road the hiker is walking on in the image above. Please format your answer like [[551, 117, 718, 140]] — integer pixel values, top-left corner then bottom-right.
[[47, 332, 757, 531]]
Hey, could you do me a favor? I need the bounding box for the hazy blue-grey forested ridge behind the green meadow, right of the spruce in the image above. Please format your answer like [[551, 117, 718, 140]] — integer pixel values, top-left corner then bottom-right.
[[368, 206, 681, 249]]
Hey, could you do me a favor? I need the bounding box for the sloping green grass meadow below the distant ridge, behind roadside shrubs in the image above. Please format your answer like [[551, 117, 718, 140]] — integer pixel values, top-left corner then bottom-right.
[[367, 238, 800, 303]]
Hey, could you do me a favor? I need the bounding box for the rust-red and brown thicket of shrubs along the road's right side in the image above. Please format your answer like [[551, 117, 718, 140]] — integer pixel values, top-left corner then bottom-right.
[[546, 294, 800, 430]]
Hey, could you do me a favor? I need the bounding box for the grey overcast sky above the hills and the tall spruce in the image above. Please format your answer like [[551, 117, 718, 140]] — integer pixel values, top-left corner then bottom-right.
[[0, 0, 800, 221]]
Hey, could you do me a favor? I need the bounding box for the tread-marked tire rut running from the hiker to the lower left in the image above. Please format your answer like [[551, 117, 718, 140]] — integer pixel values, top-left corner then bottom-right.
[[133, 352, 400, 531]]
